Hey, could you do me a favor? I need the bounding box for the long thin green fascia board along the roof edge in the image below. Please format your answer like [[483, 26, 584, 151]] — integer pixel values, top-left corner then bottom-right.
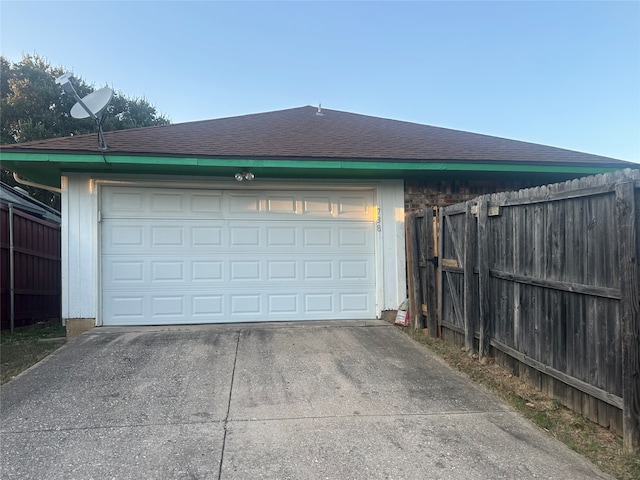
[[0, 152, 622, 174]]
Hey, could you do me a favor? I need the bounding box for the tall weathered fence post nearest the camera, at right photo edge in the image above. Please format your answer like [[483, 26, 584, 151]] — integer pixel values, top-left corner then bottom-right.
[[616, 181, 640, 453]]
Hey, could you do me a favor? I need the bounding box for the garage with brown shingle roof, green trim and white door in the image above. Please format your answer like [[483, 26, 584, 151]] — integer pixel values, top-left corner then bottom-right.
[[1, 106, 629, 331]]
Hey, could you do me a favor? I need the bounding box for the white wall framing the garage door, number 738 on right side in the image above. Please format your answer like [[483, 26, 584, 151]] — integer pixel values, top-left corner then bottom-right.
[[61, 174, 406, 325]]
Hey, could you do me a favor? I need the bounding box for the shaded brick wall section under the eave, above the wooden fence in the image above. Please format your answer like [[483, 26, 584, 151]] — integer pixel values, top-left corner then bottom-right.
[[404, 180, 537, 212]]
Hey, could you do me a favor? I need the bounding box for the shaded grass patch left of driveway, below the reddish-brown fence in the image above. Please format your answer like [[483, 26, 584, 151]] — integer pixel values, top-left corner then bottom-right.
[[0, 322, 67, 384]]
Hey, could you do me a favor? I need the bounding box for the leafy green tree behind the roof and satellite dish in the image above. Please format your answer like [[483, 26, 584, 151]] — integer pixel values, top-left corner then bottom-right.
[[0, 55, 170, 206]]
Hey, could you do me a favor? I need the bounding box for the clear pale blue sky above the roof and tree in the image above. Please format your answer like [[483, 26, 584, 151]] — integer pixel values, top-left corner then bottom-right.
[[0, 0, 640, 162]]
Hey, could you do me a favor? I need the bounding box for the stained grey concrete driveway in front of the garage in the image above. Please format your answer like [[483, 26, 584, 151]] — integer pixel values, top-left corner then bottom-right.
[[0, 321, 608, 480]]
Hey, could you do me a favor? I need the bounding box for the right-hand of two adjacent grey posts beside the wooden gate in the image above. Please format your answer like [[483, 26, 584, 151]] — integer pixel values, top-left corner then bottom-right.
[[478, 198, 491, 363]]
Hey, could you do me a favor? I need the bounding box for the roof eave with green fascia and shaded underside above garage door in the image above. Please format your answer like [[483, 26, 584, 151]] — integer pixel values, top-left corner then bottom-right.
[[0, 150, 632, 186]]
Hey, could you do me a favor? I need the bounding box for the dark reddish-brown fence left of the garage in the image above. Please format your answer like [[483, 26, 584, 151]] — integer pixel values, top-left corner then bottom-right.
[[0, 204, 61, 330]]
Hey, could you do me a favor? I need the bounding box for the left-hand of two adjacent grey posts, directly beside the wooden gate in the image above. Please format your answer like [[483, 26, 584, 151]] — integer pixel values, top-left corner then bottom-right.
[[463, 201, 477, 355]]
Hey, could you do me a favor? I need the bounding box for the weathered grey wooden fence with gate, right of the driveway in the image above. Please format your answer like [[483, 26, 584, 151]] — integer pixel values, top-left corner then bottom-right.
[[407, 170, 640, 452]]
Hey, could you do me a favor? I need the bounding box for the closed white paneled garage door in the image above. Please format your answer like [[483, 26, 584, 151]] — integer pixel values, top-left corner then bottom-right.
[[100, 187, 376, 325]]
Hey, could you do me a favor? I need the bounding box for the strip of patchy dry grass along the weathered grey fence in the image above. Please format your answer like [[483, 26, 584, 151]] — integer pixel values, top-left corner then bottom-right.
[[402, 328, 640, 480]]
